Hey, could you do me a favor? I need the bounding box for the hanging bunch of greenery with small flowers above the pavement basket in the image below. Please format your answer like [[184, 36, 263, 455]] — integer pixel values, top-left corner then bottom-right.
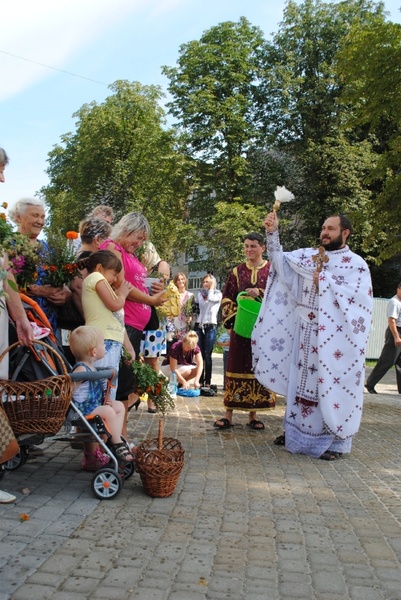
[[123, 350, 175, 417]]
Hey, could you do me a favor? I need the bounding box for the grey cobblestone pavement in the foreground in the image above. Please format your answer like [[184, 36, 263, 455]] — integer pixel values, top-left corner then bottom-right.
[[0, 357, 401, 600]]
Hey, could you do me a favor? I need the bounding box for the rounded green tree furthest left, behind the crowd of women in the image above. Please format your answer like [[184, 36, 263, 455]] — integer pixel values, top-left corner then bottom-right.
[[41, 81, 192, 260]]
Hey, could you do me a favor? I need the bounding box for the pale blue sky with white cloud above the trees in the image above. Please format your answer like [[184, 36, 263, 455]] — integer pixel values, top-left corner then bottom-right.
[[0, 0, 401, 211]]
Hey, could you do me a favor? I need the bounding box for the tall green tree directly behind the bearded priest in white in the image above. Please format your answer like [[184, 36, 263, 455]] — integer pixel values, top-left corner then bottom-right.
[[258, 0, 383, 255]]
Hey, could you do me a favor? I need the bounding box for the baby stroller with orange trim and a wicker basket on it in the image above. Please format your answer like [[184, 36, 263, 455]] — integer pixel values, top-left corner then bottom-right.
[[0, 295, 134, 499]]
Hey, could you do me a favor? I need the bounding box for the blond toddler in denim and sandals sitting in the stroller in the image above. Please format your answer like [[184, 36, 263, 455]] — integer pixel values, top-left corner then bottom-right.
[[70, 325, 134, 462]]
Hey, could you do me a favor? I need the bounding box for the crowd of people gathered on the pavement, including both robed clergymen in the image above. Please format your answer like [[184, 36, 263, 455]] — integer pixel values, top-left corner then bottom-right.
[[0, 144, 390, 502]]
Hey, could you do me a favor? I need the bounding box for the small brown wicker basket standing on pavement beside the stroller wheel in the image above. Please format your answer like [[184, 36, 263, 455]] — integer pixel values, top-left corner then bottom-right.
[[135, 430, 184, 498]]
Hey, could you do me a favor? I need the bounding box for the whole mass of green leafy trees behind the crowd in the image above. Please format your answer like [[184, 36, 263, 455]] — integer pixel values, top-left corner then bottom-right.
[[43, 0, 401, 295]]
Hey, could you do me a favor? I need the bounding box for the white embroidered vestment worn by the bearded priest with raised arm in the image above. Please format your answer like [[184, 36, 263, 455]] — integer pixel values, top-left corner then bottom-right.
[[252, 232, 373, 457]]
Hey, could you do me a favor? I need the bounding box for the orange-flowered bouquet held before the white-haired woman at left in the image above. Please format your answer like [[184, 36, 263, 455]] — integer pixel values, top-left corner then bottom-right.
[[41, 231, 81, 287]]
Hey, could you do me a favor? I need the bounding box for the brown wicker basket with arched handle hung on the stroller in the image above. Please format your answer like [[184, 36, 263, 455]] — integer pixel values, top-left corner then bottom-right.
[[0, 340, 73, 435]]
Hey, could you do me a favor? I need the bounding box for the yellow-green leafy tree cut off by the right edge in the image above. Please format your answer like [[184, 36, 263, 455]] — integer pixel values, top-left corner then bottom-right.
[[338, 19, 401, 262]]
